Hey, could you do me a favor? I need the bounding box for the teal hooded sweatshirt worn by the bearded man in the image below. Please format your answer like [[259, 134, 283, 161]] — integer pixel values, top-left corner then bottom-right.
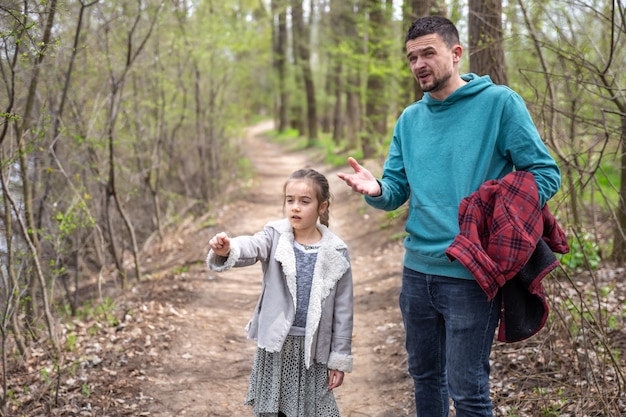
[[366, 74, 561, 279]]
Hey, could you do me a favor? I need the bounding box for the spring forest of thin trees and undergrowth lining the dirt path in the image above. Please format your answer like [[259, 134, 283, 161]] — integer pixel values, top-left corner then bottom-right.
[[0, 0, 626, 416]]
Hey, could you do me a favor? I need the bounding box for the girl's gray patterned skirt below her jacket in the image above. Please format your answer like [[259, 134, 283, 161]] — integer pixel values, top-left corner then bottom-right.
[[245, 336, 339, 417]]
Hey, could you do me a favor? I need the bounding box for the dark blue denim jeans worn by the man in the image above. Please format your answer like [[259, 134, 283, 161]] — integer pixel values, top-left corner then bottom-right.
[[400, 268, 500, 417]]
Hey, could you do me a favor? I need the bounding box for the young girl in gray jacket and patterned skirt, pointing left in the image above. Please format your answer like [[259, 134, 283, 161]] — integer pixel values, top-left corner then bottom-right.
[[207, 169, 353, 417]]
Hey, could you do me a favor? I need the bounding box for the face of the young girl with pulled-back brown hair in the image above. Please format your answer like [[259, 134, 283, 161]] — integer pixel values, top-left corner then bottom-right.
[[285, 180, 328, 235]]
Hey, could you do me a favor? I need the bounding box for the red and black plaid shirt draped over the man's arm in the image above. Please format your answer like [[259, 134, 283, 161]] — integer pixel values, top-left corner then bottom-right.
[[446, 171, 569, 341]]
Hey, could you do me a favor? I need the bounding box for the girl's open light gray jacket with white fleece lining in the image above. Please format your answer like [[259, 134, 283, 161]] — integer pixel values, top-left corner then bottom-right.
[[206, 219, 353, 372]]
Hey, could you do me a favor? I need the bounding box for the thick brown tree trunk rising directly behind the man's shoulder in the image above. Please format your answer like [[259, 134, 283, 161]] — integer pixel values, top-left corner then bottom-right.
[[469, 0, 508, 85]]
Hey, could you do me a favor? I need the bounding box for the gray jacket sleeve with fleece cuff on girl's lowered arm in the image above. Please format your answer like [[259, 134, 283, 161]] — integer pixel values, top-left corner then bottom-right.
[[328, 249, 354, 372]]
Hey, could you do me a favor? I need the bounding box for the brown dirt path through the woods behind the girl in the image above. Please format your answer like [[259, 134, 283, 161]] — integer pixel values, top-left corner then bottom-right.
[[138, 123, 414, 417]]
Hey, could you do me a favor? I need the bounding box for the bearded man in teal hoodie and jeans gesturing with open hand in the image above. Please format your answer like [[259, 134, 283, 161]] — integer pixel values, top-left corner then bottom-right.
[[338, 16, 561, 417]]
